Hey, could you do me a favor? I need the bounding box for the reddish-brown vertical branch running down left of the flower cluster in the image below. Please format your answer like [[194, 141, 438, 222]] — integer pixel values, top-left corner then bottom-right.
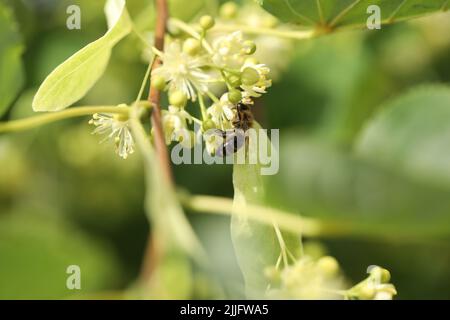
[[140, 0, 174, 285]]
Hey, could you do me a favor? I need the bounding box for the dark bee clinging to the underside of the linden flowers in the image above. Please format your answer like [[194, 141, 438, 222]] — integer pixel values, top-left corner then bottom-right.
[[216, 102, 254, 157]]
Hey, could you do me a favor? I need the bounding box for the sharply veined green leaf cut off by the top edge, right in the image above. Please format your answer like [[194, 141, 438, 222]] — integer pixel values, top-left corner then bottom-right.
[[262, 0, 448, 28]]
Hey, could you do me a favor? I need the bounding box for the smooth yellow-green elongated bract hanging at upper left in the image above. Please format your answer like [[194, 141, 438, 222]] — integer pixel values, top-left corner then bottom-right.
[[33, 0, 132, 111]]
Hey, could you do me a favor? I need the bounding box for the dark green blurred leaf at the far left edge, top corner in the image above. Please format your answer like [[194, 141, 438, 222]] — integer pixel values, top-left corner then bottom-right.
[[0, 3, 24, 117]]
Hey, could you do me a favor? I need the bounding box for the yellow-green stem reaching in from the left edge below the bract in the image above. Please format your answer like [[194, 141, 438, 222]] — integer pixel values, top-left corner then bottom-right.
[[0, 106, 130, 133]]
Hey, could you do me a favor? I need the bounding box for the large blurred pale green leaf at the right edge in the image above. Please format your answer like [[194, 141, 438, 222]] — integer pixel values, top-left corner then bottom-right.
[[356, 86, 450, 188]]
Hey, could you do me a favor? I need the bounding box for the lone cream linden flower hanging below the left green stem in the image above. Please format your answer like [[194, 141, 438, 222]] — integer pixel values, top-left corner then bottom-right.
[[89, 113, 134, 159]]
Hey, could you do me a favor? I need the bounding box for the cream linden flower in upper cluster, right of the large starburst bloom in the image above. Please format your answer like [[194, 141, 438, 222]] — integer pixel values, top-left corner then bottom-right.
[[212, 31, 246, 69]]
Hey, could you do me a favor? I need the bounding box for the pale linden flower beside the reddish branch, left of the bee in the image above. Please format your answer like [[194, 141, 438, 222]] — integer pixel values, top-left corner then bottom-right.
[[162, 106, 192, 144]]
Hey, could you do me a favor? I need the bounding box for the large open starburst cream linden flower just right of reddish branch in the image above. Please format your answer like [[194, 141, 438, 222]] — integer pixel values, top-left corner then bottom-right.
[[152, 41, 211, 101]]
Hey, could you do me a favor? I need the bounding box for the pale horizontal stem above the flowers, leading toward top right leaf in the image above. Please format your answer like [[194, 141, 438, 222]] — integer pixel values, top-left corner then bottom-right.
[[213, 24, 316, 40]]
